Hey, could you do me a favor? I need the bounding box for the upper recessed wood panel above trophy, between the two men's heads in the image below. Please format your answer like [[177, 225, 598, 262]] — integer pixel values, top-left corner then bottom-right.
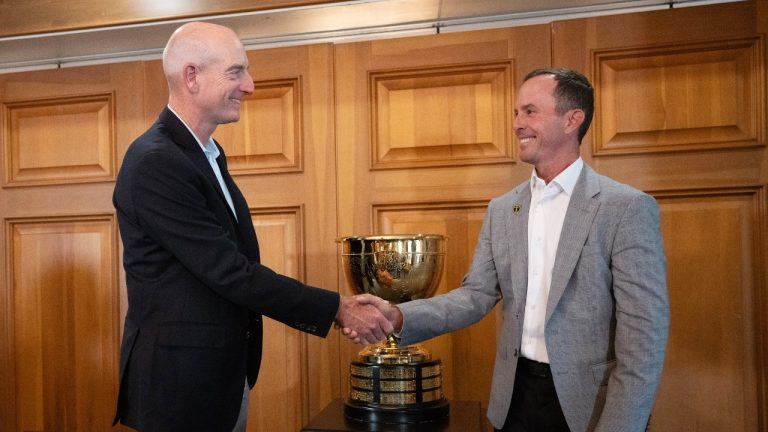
[[369, 62, 513, 169]]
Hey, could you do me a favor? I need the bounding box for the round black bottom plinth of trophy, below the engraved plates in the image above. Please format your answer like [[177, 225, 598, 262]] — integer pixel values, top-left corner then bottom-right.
[[344, 399, 449, 424]]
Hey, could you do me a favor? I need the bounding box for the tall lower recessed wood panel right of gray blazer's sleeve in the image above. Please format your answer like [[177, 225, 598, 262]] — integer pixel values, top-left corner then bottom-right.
[[652, 187, 768, 431]]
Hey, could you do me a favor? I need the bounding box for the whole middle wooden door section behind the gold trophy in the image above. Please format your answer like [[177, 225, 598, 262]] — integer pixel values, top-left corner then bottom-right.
[[335, 26, 550, 428]]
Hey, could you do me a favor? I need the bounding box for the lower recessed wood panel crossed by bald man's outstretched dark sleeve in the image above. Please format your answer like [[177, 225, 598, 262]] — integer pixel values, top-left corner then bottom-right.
[[247, 208, 309, 432]]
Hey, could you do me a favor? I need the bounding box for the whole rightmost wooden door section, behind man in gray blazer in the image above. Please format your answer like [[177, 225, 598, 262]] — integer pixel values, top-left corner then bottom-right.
[[553, 2, 768, 431]]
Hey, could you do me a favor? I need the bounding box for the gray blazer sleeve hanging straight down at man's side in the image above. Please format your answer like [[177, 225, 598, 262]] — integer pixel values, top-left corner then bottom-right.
[[595, 194, 669, 432]]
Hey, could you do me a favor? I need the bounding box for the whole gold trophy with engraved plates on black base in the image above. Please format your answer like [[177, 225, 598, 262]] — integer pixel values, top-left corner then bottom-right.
[[339, 234, 449, 424]]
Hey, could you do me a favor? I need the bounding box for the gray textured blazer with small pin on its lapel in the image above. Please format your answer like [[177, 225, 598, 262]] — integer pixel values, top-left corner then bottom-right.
[[400, 164, 669, 432]]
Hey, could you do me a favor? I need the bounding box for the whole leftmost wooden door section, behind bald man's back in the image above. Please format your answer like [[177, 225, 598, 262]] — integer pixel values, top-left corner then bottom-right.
[[0, 63, 142, 431]]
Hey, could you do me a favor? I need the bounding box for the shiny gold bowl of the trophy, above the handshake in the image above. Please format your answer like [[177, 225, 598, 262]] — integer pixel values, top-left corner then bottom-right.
[[339, 234, 445, 304]]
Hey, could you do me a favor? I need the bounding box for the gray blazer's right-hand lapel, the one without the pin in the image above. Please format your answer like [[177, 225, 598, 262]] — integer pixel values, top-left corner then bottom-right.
[[546, 164, 600, 321]]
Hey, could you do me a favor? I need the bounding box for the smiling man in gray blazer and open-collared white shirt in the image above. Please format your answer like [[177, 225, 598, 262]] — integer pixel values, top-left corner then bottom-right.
[[353, 69, 669, 432]]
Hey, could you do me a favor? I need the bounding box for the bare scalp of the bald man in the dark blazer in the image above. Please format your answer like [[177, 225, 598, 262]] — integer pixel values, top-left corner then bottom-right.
[[163, 22, 243, 92]]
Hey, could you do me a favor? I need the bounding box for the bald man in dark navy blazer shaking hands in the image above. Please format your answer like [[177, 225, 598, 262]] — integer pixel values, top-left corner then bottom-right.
[[113, 23, 392, 432]]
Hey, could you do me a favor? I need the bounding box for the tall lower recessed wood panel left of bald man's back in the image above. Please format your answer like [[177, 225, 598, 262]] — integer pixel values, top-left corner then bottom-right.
[[3, 216, 120, 431]]
